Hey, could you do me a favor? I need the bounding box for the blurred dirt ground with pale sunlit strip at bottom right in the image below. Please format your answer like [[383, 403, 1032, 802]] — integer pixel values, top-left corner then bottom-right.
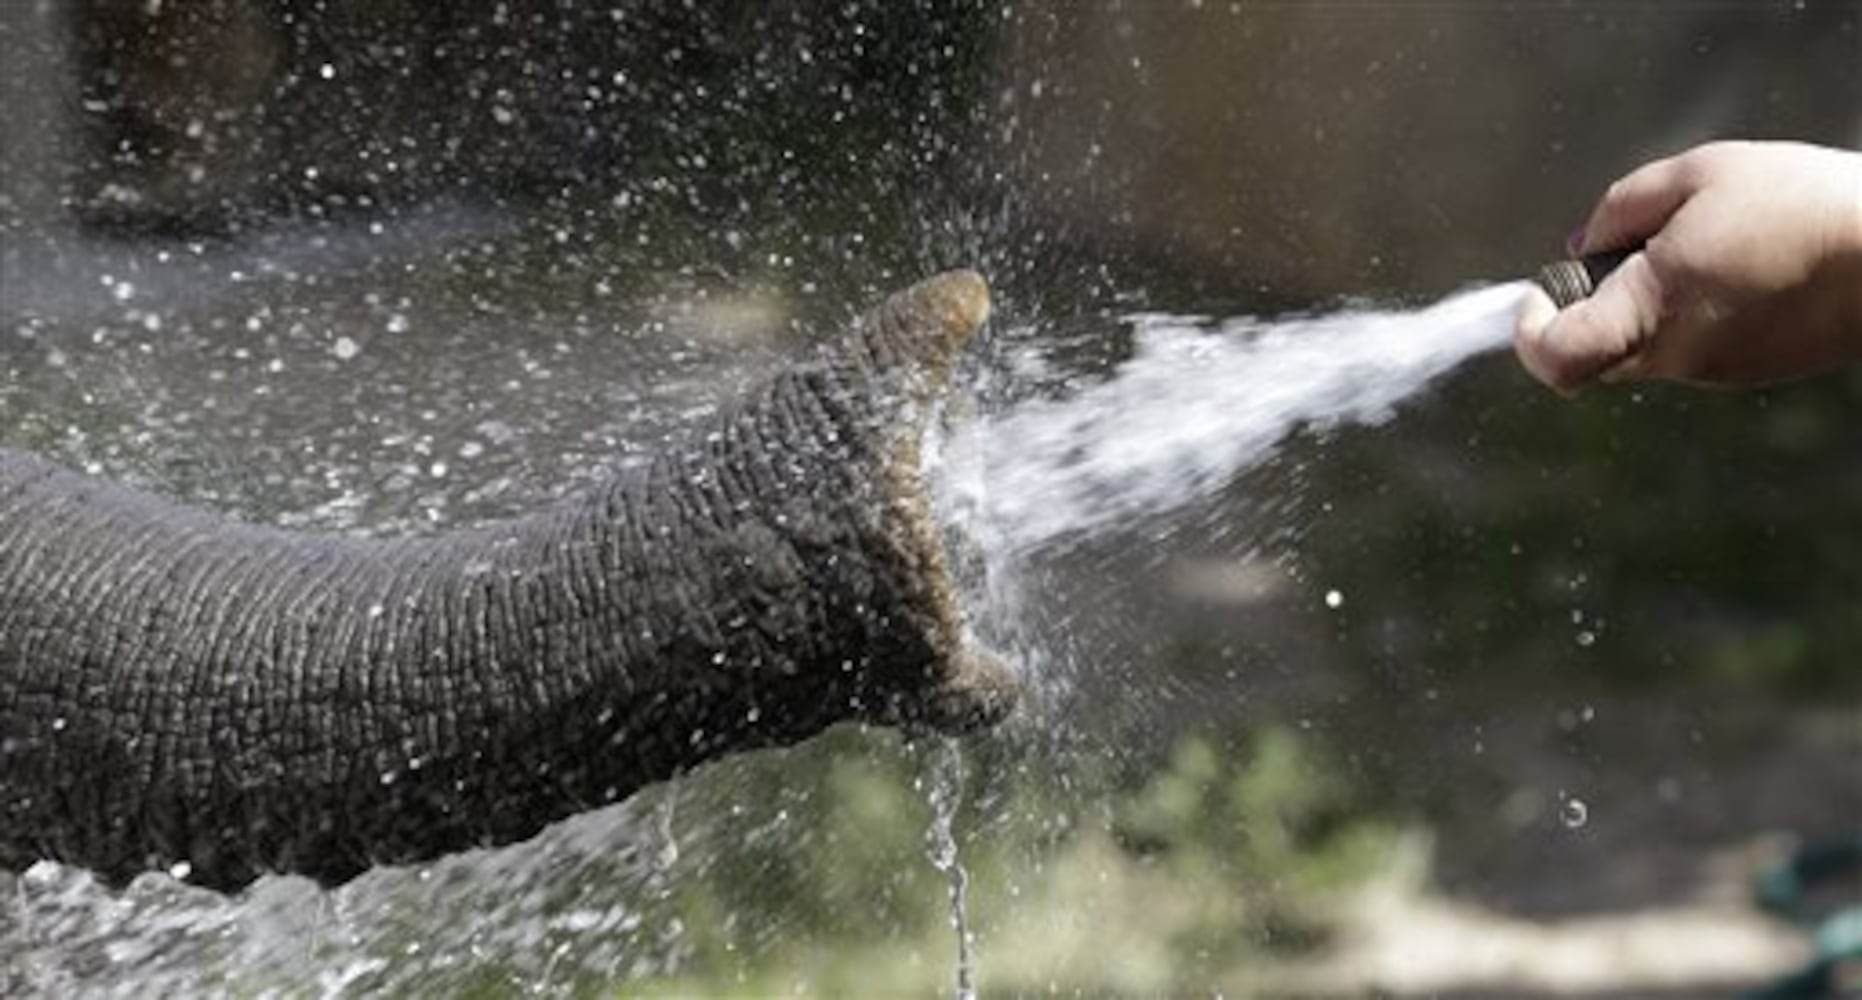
[[1307, 700, 1862, 996]]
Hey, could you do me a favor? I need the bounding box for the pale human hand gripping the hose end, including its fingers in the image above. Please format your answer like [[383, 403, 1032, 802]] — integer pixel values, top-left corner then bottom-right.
[[1514, 142, 1862, 393]]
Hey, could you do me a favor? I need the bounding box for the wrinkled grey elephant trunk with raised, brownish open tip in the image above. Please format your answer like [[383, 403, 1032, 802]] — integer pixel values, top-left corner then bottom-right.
[[0, 272, 1015, 890]]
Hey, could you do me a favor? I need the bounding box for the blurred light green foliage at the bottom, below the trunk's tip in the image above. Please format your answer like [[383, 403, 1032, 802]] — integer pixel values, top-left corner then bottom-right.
[[626, 728, 1395, 996]]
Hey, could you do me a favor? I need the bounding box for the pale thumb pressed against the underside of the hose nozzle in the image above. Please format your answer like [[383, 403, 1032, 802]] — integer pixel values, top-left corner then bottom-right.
[[1518, 251, 1663, 391]]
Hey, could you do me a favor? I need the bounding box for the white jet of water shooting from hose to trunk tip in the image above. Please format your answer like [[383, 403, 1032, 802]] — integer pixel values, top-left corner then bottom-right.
[[937, 283, 1529, 562]]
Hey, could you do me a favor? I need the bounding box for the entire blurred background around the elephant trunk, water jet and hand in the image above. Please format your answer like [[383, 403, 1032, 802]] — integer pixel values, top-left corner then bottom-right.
[[0, 0, 1862, 996]]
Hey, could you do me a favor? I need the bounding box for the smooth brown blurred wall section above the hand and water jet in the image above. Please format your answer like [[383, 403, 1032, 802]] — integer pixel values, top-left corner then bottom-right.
[[1002, 0, 1862, 298]]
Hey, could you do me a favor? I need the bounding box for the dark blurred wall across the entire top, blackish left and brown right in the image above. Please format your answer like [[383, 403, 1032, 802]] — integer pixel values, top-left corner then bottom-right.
[[18, 0, 1862, 292]]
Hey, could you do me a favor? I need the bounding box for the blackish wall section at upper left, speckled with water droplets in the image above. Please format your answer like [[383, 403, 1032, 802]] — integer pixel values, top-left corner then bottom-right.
[[54, 0, 981, 229]]
